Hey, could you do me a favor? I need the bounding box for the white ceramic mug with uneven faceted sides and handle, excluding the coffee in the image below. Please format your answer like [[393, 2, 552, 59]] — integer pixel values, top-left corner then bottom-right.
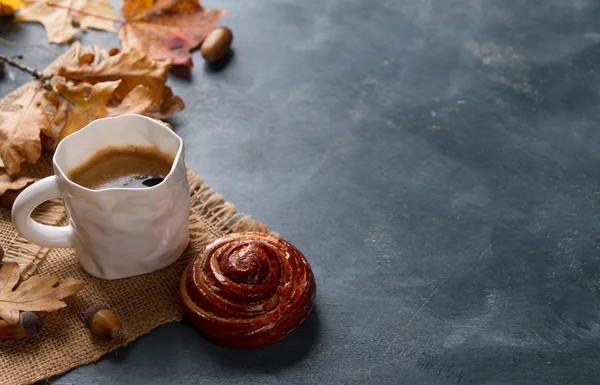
[[12, 115, 189, 279]]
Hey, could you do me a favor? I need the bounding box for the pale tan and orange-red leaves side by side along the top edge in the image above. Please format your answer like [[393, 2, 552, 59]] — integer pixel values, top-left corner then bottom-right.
[[0, 0, 227, 67]]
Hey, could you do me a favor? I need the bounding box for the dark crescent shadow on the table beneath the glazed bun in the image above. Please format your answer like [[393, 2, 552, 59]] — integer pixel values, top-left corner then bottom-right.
[[199, 307, 320, 373]]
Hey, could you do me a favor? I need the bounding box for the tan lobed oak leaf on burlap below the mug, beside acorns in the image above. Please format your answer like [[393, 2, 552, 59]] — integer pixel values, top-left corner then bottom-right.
[[0, 262, 85, 325]]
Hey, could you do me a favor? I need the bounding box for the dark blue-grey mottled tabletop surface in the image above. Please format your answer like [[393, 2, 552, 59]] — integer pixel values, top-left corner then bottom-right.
[[0, 0, 600, 385]]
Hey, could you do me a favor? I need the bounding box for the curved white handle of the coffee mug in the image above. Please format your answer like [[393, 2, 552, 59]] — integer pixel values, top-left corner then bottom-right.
[[12, 175, 73, 247]]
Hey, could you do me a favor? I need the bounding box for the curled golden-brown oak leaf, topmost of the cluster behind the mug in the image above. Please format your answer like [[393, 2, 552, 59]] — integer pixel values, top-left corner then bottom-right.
[[58, 49, 185, 119]]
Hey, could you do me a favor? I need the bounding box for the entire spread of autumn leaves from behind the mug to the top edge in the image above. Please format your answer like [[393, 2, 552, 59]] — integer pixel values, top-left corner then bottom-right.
[[0, 0, 227, 207]]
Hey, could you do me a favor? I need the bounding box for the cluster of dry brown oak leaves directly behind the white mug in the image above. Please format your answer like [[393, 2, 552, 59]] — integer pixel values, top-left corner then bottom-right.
[[0, 43, 184, 202]]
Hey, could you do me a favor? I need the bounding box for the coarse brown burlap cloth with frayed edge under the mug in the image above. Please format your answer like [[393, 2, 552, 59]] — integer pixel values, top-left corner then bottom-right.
[[0, 54, 268, 385]]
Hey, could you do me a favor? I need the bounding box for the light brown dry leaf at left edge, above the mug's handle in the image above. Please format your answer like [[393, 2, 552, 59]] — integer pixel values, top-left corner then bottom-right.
[[0, 82, 60, 175]]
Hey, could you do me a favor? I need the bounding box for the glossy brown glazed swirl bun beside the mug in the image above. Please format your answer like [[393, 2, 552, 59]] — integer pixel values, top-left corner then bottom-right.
[[180, 233, 316, 348]]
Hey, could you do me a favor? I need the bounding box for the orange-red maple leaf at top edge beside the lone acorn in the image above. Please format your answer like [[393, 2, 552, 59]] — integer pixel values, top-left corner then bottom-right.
[[119, 0, 228, 67]]
